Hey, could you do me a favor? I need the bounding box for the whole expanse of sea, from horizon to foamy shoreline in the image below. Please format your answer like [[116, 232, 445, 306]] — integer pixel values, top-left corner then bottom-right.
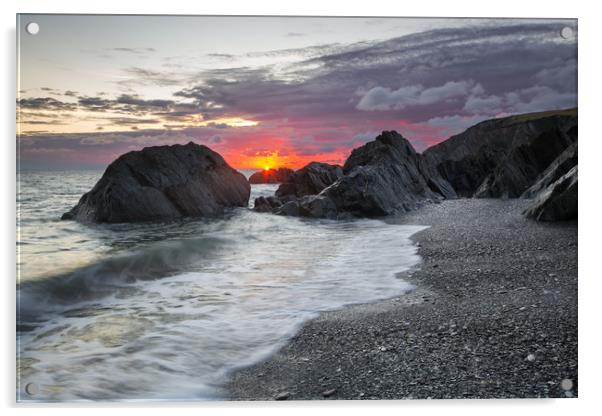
[[17, 171, 424, 401]]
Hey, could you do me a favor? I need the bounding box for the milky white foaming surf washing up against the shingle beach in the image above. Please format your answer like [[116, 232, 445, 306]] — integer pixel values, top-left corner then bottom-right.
[[20, 184, 424, 400]]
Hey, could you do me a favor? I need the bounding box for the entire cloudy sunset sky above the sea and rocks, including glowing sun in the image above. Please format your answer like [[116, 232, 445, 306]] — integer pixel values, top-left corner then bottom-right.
[[17, 15, 577, 169]]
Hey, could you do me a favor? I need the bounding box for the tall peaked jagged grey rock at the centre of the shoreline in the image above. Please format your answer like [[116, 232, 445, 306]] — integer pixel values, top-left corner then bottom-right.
[[299, 131, 455, 218]]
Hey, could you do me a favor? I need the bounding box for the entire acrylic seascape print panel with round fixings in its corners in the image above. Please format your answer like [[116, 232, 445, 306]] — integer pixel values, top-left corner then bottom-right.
[[16, 15, 578, 402]]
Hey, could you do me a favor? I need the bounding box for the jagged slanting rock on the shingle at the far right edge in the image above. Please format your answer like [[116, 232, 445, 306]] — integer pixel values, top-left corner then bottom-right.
[[523, 166, 578, 221]]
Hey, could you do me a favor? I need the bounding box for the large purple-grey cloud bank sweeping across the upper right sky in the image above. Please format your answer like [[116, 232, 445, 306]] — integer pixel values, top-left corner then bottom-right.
[[175, 20, 576, 128]]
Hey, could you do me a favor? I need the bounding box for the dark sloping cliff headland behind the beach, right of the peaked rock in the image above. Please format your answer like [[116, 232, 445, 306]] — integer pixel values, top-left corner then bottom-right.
[[423, 109, 577, 197]]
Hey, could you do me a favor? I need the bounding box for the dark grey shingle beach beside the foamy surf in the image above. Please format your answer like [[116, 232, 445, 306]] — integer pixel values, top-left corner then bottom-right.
[[226, 199, 578, 400]]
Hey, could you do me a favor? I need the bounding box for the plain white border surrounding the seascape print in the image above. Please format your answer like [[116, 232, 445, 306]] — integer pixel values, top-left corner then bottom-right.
[[0, 0, 602, 416]]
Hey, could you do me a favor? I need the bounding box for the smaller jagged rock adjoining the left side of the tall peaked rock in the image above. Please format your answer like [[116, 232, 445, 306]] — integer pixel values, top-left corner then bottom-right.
[[276, 162, 343, 198]]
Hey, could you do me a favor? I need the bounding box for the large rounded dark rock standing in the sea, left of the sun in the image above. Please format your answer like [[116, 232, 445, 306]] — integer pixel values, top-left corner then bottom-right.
[[62, 142, 250, 223]]
